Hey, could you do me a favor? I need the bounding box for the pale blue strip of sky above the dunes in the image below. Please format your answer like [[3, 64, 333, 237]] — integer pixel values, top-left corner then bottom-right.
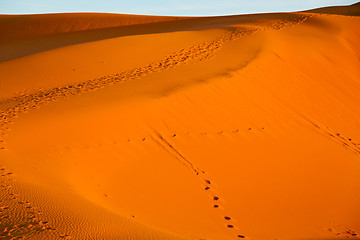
[[0, 0, 359, 16]]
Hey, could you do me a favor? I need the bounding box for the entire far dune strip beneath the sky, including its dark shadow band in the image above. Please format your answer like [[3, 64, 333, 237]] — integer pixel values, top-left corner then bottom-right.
[[0, 14, 306, 61]]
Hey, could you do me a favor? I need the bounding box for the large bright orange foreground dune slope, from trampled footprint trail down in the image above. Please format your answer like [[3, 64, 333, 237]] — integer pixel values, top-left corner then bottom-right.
[[1, 3, 360, 239]]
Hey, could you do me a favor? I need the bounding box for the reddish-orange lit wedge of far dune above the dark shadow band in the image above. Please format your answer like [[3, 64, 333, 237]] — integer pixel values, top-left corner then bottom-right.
[[1, 13, 186, 42]]
